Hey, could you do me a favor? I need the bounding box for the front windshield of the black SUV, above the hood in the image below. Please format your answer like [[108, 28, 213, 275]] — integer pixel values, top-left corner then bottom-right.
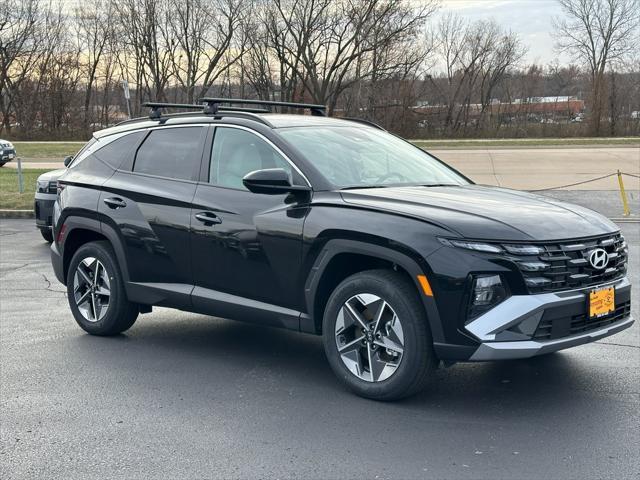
[[278, 126, 469, 188]]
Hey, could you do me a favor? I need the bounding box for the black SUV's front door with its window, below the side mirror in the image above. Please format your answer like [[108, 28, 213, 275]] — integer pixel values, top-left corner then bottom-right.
[[191, 126, 309, 315]]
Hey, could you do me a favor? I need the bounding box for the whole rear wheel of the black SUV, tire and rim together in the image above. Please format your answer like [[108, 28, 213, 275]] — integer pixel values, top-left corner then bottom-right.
[[67, 241, 139, 336]]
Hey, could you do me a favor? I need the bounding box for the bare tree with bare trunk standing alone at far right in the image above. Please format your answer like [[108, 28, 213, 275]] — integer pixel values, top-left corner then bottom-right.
[[555, 0, 640, 136]]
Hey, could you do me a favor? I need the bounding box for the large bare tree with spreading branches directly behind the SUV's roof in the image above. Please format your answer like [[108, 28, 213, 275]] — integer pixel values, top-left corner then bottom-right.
[[275, 0, 436, 112]]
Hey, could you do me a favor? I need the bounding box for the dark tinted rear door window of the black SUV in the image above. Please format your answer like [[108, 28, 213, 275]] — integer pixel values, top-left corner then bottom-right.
[[133, 127, 204, 180]]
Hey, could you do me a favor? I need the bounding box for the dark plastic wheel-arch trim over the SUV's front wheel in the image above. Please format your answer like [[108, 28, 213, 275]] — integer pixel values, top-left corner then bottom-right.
[[300, 239, 444, 342]]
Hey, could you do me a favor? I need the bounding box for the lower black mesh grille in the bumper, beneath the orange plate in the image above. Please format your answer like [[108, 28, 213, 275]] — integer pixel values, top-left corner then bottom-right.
[[533, 300, 631, 340]]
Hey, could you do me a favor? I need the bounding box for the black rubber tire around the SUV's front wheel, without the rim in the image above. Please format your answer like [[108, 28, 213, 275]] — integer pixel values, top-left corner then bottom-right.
[[323, 271, 432, 400]]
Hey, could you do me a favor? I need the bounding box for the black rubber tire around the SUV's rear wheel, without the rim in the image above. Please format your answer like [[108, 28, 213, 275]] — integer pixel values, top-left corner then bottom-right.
[[67, 242, 128, 335]]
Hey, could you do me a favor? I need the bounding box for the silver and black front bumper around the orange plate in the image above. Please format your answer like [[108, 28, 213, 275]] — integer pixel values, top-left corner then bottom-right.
[[465, 277, 634, 361]]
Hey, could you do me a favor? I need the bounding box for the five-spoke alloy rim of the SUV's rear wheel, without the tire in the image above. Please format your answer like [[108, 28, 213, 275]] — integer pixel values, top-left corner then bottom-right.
[[73, 257, 111, 322]]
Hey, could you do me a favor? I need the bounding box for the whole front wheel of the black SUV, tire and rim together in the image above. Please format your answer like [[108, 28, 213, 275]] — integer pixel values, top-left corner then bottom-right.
[[322, 270, 438, 401]]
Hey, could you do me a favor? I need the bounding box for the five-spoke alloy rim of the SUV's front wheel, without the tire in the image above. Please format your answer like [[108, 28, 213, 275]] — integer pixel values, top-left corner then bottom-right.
[[335, 293, 404, 382]]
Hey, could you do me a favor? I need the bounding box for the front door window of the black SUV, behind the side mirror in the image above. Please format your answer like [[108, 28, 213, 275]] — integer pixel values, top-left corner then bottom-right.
[[209, 127, 291, 189]]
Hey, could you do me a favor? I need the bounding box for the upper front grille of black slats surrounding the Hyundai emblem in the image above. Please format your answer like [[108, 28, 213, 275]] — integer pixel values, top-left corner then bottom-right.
[[509, 234, 628, 293]]
